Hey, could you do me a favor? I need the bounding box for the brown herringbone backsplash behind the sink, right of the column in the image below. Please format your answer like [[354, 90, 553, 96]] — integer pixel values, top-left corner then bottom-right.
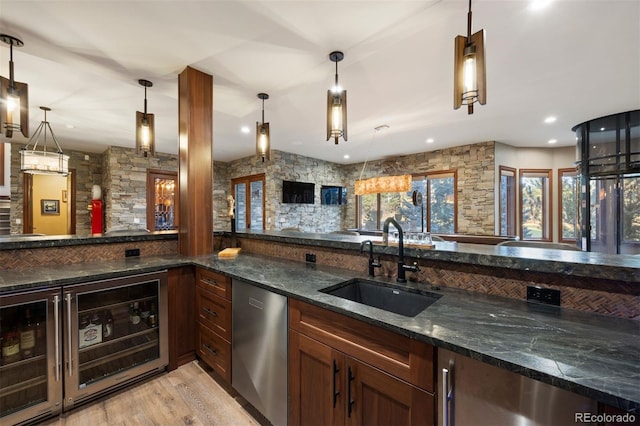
[[239, 239, 640, 318]]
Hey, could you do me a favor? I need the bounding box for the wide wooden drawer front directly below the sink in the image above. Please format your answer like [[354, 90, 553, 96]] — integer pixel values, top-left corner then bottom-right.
[[289, 299, 435, 392]]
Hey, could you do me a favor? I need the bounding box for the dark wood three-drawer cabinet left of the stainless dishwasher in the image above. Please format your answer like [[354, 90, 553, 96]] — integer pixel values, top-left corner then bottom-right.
[[195, 268, 231, 384]]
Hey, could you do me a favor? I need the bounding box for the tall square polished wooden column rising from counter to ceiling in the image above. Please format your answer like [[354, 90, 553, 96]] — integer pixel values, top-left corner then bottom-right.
[[178, 67, 213, 256]]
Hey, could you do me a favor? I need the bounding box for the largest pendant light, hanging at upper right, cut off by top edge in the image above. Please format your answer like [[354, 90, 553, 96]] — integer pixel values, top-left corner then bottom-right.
[[453, 0, 487, 114]]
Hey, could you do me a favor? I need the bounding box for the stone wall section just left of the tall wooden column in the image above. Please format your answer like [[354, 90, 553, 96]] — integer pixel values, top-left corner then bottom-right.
[[102, 146, 178, 232]]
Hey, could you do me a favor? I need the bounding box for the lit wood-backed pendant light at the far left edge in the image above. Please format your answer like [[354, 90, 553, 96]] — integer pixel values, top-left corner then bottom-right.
[[0, 34, 29, 138]]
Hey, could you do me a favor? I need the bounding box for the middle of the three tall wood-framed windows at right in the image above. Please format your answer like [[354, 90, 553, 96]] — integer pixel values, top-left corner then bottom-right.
[[520, 169, 551, 241]]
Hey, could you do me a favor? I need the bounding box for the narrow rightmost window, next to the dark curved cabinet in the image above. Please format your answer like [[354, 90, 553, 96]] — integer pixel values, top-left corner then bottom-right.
[[558, 169, 580, 243]]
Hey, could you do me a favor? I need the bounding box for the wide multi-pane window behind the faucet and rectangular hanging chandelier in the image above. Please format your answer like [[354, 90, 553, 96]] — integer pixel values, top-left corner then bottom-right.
[[356, 171, 457, 234]]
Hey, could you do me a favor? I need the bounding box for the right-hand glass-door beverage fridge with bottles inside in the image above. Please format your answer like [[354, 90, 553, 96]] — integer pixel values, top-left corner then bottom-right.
[[62, 271, 169, 410]]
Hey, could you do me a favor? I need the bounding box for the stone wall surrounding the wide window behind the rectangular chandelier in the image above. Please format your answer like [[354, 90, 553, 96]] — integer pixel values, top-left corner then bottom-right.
[[344, 142, 495, 235]]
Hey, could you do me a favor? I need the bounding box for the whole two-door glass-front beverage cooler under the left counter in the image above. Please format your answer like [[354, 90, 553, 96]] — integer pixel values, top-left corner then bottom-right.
[[0, 271, 168, 425]]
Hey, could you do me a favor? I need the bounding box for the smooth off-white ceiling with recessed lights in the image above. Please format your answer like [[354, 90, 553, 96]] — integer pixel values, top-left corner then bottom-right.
[[0, 0, 640, 164]]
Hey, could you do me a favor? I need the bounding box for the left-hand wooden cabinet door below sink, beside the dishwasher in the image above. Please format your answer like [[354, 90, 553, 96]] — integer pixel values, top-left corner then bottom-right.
[[289, 330, 346, 425]]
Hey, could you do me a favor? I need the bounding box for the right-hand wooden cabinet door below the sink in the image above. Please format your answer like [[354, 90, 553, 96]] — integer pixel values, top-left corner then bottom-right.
[[345, 357, 435, 426]]
